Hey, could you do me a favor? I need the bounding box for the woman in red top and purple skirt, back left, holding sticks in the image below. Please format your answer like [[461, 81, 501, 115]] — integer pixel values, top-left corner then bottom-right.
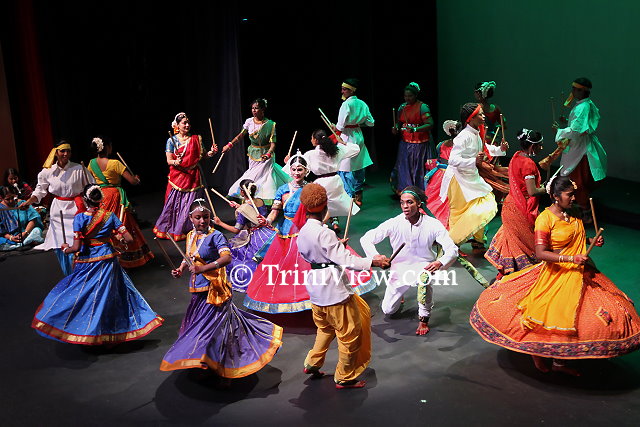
[[153, 113, 209, 240]]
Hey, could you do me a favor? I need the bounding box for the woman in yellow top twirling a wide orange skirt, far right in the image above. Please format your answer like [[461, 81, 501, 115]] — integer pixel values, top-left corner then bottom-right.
[[470, 176, 640, 375]]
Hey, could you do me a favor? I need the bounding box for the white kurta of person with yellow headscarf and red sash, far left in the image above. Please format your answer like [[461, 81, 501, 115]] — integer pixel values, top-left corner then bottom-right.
[[32, 162, 95, 250]]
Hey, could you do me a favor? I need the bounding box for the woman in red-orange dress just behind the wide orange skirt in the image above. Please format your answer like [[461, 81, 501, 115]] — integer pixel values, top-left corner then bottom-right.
[[484, 129, 546, 279]]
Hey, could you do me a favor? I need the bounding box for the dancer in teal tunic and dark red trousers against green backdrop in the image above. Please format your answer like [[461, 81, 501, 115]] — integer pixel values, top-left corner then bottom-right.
[[554, 77, 607, 214]]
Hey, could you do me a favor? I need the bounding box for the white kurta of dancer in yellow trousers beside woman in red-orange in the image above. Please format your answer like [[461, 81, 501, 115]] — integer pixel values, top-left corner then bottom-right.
[[440, 125, 506, 202]]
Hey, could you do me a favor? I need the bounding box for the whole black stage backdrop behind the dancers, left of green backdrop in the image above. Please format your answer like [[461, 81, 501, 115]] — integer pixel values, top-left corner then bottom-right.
[[3, 0, 441, 194]]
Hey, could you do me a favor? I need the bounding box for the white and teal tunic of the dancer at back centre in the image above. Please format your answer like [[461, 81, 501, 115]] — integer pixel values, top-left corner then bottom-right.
[[336, 95, 374, 172]]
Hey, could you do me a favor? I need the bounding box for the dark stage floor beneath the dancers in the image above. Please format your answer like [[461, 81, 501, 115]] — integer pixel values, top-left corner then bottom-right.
[[0, 174, 640, 426]]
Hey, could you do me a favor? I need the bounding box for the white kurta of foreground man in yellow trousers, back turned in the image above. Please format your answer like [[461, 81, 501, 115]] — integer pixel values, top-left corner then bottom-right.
[[297, 219, 373, 306]]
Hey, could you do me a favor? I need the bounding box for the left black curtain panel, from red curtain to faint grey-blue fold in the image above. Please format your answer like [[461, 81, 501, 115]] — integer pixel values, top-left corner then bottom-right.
[[27, 1, 246, 194]]
